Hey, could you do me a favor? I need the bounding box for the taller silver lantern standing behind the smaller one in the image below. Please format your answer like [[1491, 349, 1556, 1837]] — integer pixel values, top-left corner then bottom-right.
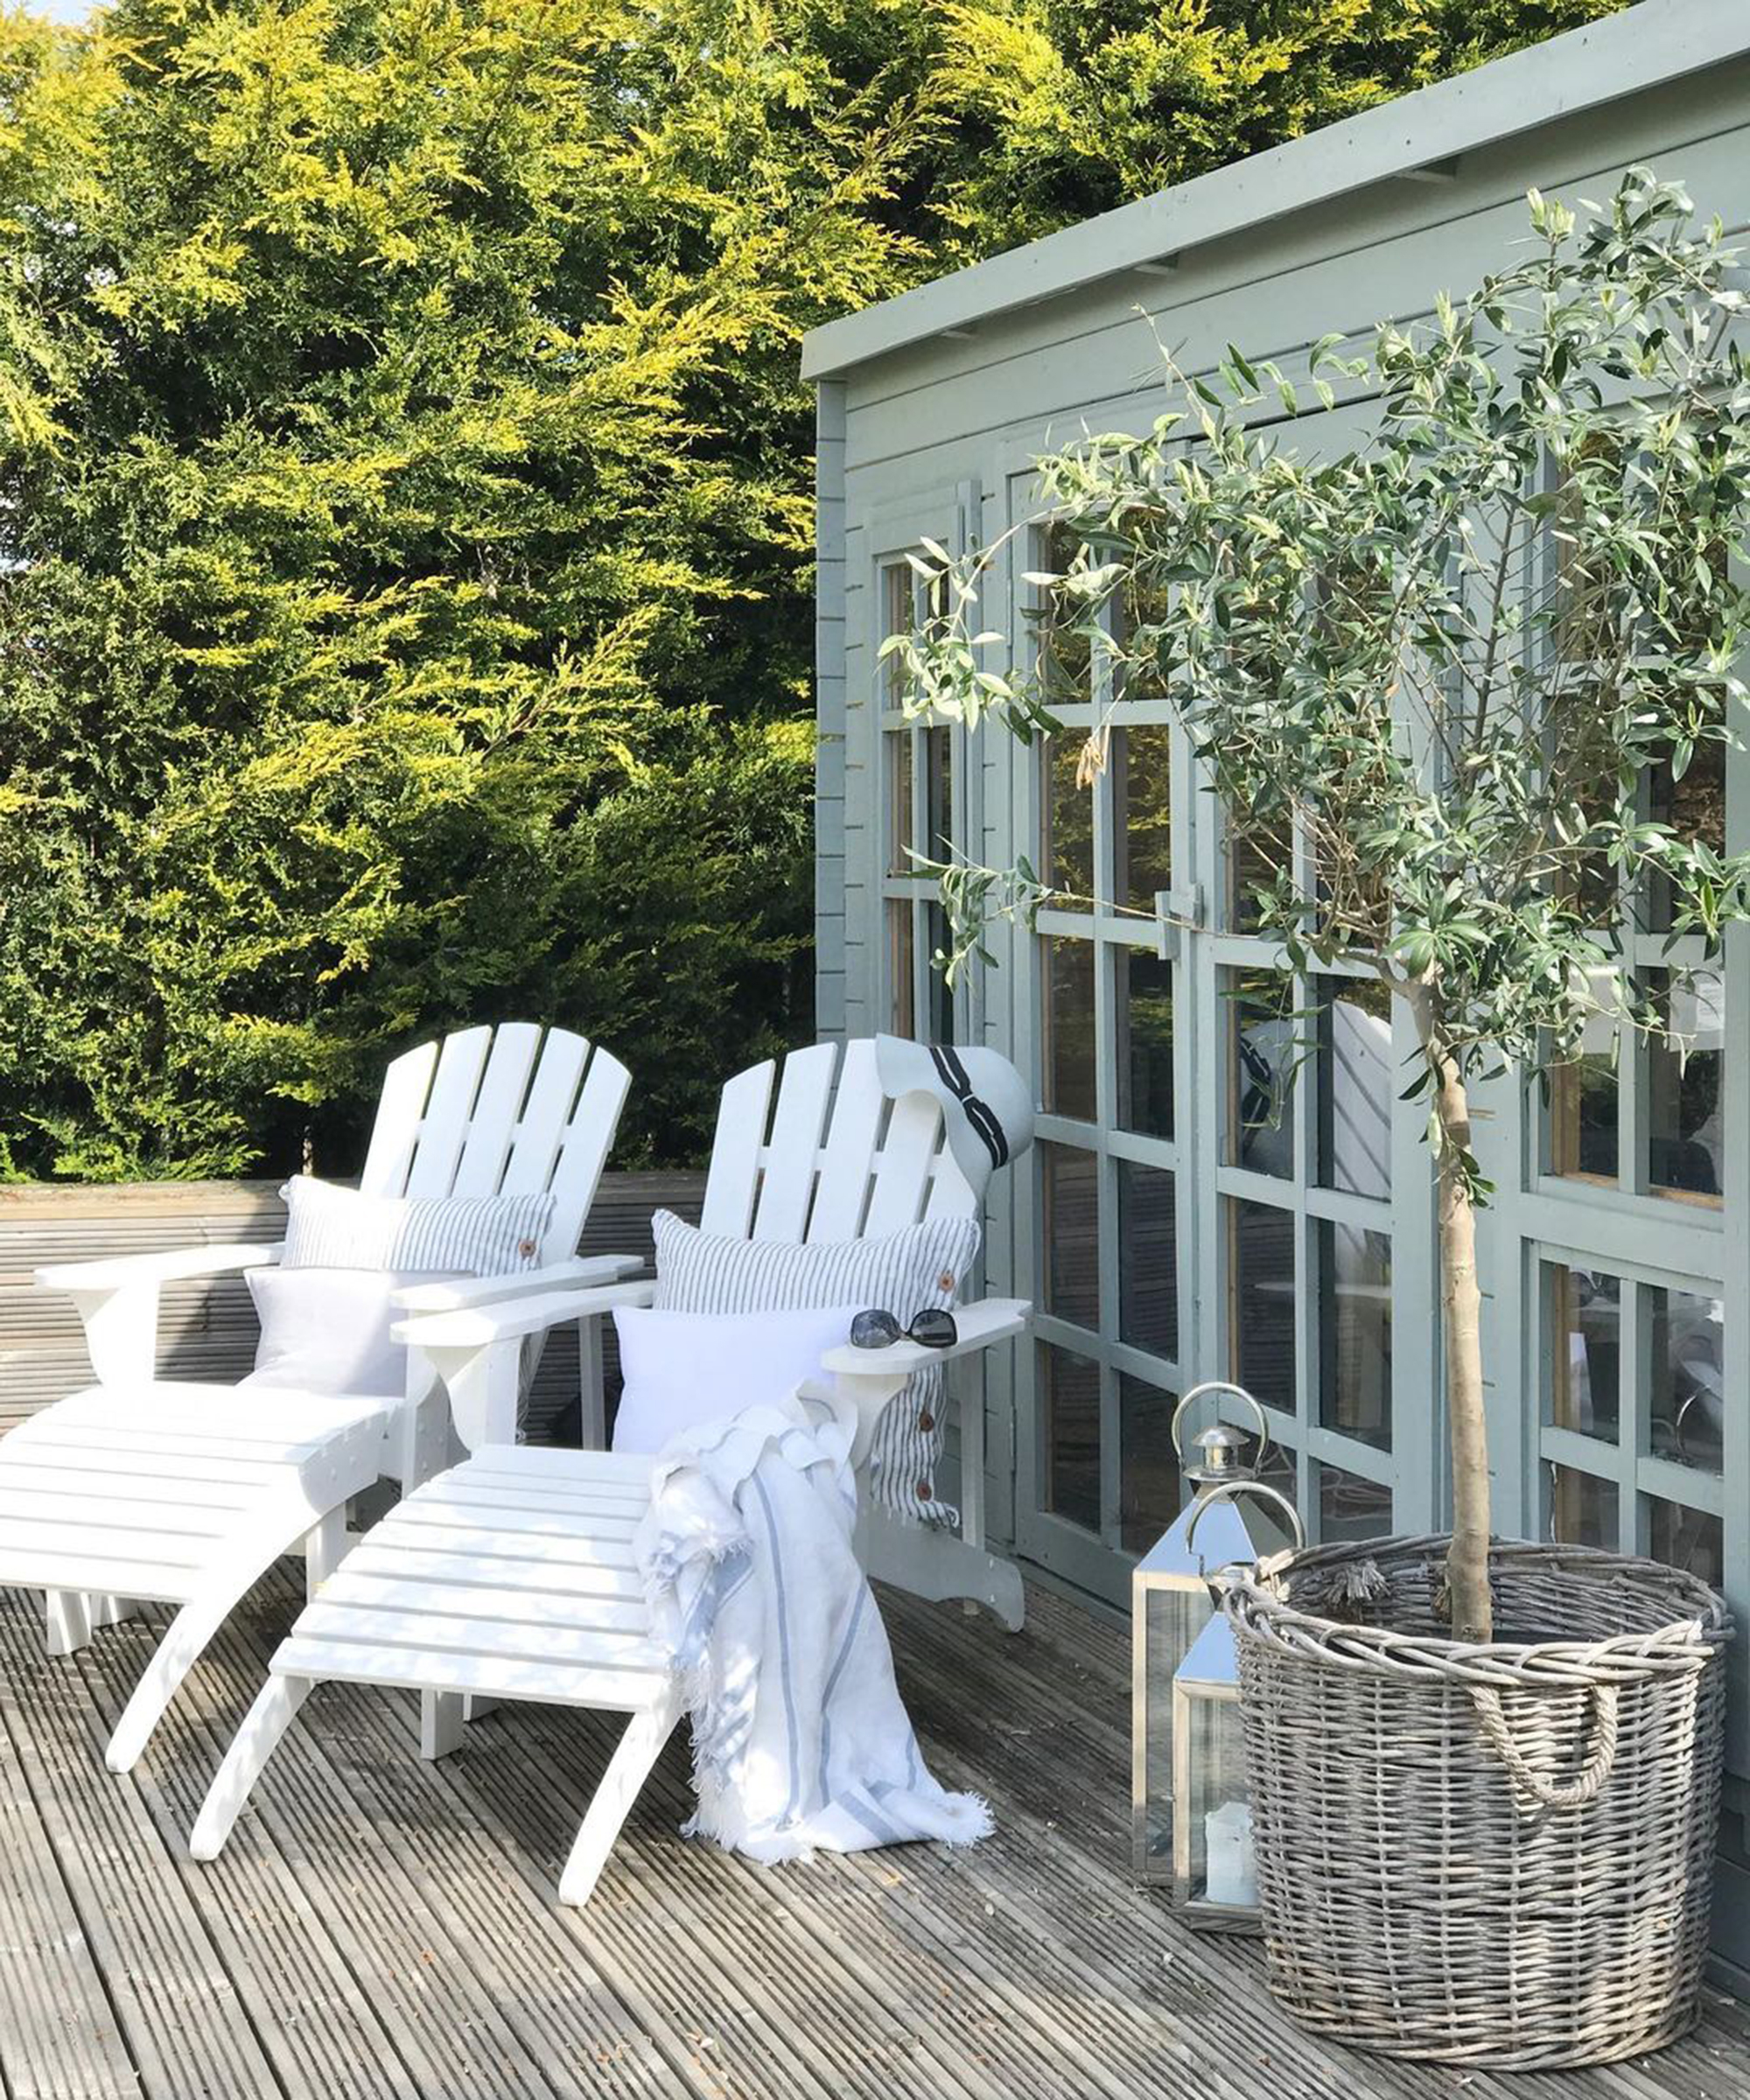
[[1130, 1380, 1292, 1886]]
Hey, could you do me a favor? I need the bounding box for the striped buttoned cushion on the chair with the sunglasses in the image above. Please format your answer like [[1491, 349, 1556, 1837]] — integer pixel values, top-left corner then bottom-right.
[[651, 1209, 979, 1524]]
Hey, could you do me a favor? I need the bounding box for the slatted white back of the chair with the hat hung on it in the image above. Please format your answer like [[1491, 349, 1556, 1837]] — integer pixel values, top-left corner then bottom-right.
[[700, 1038, 990, 1243]]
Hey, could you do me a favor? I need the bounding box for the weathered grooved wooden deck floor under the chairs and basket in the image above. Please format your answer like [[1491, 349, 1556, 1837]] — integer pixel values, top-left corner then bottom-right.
[[0, 1566, 1750, 2100]]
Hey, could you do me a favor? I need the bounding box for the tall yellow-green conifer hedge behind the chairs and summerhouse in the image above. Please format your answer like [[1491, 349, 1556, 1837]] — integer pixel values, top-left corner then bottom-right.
[[0, 0, 1609, 1176]]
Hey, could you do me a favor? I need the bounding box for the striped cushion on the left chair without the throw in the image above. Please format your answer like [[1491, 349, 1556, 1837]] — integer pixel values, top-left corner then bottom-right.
[[279, 1174, 552, 1277]]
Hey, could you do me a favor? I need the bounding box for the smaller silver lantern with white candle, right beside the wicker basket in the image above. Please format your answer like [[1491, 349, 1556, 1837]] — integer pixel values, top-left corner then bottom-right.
[[1172, 1480, 1305, 1932]]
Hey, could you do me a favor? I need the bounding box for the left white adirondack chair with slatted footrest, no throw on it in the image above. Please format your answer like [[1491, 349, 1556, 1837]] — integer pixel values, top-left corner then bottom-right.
[[0, 1023, 640, 1773]]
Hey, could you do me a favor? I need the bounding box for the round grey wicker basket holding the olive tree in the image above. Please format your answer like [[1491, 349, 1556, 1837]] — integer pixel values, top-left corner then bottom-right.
[[1227, 1537, 1731, 2070]]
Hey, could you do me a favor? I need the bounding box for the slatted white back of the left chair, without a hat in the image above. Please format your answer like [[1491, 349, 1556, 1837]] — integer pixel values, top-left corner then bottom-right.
[[360, 1020, 630, 1264]]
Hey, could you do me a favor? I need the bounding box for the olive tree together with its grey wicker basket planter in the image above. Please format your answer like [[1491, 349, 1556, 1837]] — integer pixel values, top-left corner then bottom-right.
[[886, 170, 1750, 2064]]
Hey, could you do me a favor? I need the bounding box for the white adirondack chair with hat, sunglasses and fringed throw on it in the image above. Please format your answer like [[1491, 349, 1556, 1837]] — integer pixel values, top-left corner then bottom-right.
[[191, 1041, 1027, 1905]]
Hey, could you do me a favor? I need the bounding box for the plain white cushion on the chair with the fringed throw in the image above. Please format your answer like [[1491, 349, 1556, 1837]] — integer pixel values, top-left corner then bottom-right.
[[613, 1306, 864, 1453]]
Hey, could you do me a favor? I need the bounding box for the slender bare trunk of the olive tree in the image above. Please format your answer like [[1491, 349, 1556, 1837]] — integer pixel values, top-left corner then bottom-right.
[[1411, 985, 1494, 1642]]
